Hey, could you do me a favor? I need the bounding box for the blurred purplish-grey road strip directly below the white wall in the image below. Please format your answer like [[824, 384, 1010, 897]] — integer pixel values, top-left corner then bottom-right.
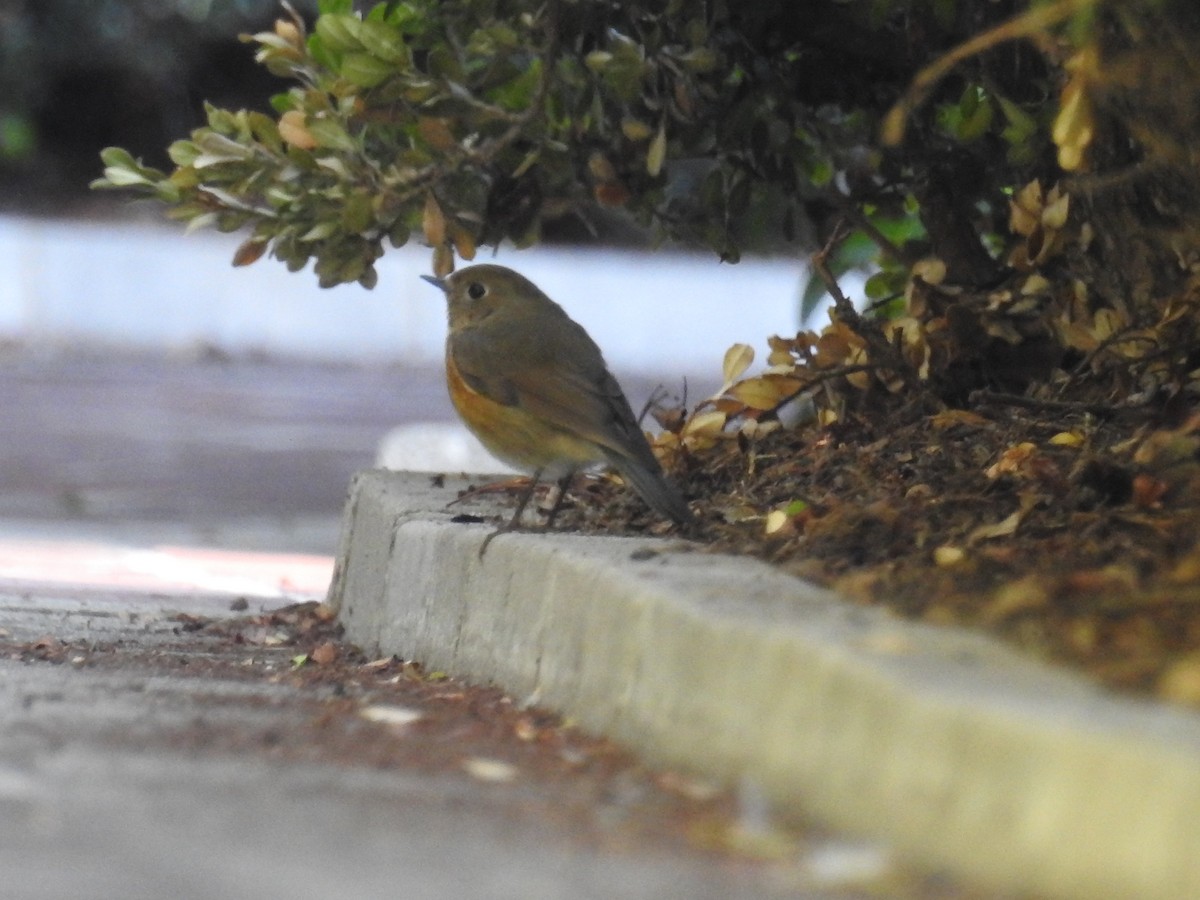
[[0, 349, 452, 535]]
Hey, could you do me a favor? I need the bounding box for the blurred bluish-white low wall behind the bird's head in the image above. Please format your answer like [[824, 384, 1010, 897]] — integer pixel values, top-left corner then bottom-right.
[[0, 217, 803, 382]]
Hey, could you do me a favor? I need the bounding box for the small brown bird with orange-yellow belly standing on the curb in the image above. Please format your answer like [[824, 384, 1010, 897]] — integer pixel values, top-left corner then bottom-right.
[[421, 265, 691, 530]]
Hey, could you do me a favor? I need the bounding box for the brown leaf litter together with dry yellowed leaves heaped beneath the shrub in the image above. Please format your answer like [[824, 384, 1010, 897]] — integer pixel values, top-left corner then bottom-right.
[[535, 182, 1200, 706]]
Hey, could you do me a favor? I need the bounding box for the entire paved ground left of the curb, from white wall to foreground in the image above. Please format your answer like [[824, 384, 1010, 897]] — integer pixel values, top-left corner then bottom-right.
[[0, 350, 962, 900]]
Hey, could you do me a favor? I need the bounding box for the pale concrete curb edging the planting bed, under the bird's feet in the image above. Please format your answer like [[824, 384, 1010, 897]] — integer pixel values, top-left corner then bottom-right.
[[330, 470, 1200, 900]]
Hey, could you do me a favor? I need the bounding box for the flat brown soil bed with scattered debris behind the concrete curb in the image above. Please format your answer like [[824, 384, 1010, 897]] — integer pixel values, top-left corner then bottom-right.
[[511, 374, 1200, 706]]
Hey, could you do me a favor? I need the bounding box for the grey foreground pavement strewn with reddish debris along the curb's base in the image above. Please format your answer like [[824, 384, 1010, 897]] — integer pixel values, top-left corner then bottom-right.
[[0, 571, 854, 900]]
